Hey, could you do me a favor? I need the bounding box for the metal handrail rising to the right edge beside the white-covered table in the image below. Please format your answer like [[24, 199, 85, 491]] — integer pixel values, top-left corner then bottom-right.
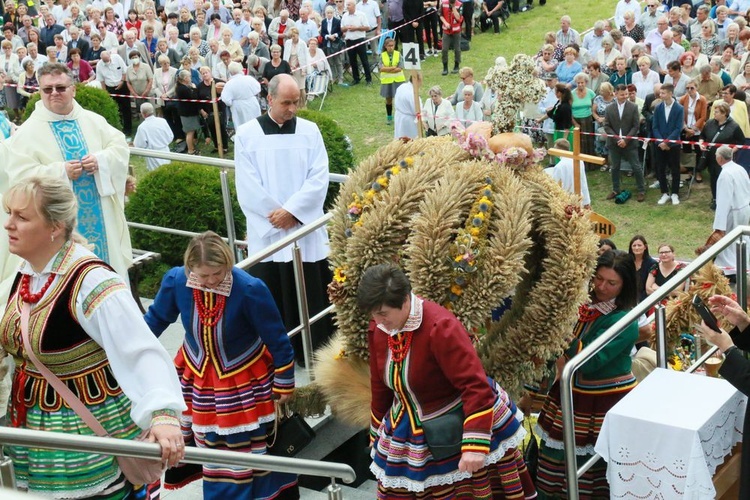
[[560, 226, 750, 500]]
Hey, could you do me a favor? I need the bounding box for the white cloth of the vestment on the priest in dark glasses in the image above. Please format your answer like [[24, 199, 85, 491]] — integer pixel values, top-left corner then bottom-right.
[[0, 97, 133, 300]]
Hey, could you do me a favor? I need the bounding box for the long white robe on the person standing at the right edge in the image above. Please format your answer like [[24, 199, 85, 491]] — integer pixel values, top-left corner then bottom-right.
[[714, 161, 750, 274]]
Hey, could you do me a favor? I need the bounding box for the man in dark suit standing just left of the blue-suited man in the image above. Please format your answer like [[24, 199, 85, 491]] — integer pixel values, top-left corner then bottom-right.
[[604, 84, 646, 202]]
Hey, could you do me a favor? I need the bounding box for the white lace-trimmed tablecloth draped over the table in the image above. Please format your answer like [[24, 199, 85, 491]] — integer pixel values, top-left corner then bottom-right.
[[595, 369, 747, 500]]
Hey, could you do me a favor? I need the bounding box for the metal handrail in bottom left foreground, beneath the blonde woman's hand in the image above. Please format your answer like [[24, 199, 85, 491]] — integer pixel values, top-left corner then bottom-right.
[[0, 427, 357, 484]]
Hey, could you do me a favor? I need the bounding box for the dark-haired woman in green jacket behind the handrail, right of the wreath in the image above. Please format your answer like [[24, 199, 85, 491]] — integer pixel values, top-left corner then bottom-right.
[[537, 250, 638, 499]]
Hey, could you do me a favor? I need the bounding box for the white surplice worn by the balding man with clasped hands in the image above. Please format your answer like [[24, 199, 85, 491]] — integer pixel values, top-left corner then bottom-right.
[[234, 118, 328, 262]]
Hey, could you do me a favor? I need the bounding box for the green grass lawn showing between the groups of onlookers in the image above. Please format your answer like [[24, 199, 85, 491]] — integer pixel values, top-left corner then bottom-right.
[[134, 0, 713, 259]]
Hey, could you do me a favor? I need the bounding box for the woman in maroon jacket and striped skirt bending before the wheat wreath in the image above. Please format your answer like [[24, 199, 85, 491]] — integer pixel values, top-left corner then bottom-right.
[[357, 264, 536, 500]]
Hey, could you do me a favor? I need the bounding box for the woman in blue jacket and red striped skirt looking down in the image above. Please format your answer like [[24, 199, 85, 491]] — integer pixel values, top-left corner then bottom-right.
[[146, 231, 299, 500]]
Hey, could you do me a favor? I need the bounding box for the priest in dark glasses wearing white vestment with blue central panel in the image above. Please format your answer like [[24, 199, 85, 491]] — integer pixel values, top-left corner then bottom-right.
[[0, 63, 133, 300]]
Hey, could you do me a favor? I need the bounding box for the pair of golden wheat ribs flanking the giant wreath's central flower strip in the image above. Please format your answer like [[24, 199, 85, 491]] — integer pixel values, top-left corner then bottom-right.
[[404, 162, 531, 331]]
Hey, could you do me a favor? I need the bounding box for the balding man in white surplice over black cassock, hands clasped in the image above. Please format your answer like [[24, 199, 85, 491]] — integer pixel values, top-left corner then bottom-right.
[[235, 74, 332, 364]]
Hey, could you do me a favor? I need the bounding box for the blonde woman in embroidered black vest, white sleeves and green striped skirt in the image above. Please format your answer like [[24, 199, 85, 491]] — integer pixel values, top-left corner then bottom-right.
[[0, 177, 185, 500]]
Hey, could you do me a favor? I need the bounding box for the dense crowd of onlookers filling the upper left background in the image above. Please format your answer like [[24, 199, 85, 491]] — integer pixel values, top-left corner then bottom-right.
[[0, 0, 531, 148]]
